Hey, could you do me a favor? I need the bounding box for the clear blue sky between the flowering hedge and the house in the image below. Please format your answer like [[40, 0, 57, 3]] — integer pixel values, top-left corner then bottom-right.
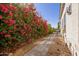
[[35, 3, 60, 27]]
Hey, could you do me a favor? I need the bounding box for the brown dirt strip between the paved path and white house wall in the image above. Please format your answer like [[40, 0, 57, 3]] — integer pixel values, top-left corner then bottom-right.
[[47, 37, 71, 56]]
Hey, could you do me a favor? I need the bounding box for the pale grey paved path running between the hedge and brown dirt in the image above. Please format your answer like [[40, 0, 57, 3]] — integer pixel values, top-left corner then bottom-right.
[[24, 34, 55, 56]]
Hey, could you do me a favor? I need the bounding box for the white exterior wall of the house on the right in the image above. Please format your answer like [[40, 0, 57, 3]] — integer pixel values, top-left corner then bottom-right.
[[61, 3, 79, 55]]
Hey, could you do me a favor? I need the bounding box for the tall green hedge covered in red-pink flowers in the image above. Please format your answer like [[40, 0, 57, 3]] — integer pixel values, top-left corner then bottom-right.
[[0, 4, 48, 47]]
